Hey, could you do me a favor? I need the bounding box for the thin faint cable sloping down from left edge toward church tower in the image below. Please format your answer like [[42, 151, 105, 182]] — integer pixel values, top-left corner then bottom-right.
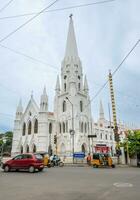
[[0, 44, 58, 70]]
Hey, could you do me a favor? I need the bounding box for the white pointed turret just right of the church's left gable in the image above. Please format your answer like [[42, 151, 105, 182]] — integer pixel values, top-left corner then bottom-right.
[[40, 86, 48, 112]]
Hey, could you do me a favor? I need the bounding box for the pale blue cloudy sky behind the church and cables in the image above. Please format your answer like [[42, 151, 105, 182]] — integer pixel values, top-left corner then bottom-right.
[[0, 0, 140, 132]]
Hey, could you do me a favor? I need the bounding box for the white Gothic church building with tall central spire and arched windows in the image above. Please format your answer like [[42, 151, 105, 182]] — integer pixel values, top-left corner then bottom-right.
[[12, 17, 115, 156]]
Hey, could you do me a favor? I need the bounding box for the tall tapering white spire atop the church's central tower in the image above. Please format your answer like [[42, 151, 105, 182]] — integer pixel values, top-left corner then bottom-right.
[[65, 14, 78, 58]]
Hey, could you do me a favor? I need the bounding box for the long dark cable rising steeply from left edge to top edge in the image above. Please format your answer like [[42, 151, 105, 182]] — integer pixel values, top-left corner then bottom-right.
[[0, 0, 59, 43]]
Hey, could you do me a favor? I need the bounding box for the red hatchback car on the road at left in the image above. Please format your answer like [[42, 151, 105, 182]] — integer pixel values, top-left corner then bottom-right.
[[2, 153, 44, 173]]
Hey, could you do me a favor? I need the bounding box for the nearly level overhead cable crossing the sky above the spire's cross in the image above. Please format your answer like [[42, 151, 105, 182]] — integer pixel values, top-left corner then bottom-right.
[[0, 0, 117, 20]]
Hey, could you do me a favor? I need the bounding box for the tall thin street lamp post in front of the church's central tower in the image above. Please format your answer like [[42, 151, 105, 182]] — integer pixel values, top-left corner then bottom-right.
[[66, 97, 74, 164]]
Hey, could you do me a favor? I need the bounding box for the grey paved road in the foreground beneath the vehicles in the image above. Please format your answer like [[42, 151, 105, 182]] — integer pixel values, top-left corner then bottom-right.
[[0, 167, 140, 200]]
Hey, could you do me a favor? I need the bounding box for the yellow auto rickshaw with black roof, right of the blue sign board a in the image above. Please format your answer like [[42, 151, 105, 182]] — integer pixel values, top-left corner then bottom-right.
[[91, 153, 115, 168]]
